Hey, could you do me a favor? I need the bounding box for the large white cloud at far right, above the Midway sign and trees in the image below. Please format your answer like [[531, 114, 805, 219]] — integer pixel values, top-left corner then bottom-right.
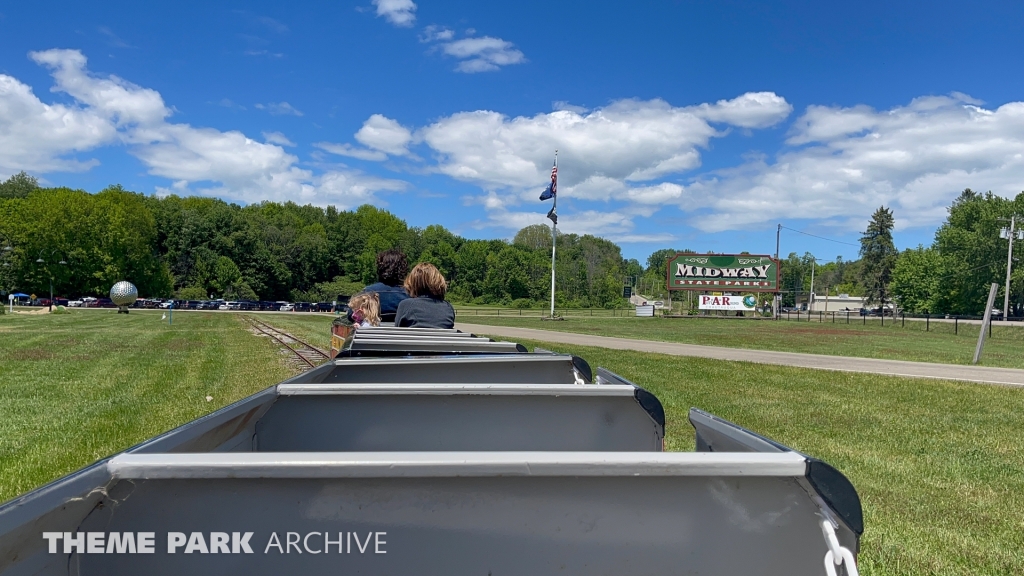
[[685, 94, 1024, 232]]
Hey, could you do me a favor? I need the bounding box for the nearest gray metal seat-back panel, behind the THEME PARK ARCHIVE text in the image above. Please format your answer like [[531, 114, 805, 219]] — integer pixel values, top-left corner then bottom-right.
[[68, 476, 826, 576]]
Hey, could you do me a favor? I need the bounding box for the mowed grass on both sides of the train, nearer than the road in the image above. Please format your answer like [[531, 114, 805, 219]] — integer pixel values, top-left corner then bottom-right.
[[0, 311, 1024, 575]]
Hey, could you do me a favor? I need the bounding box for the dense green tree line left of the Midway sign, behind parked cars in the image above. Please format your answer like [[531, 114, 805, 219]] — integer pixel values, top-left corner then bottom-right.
[[0, 173, 640, 307]]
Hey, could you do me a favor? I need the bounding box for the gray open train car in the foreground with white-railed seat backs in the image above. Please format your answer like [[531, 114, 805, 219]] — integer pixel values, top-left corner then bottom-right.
[[0, 338, 863, 576]]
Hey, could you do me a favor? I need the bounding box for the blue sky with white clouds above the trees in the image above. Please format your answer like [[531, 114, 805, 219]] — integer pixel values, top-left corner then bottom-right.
[[0, 0, 1024, 261]]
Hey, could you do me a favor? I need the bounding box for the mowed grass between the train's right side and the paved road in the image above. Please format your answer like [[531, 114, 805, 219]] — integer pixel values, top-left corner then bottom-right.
[[483, 334, 1024, 575]]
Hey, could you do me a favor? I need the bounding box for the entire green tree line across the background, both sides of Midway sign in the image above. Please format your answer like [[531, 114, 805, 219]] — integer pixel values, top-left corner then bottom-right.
[[0, 172, 1024, 316]]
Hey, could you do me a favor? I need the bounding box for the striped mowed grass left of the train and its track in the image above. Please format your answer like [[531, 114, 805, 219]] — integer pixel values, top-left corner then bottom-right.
[[0, 311, 290, 501]]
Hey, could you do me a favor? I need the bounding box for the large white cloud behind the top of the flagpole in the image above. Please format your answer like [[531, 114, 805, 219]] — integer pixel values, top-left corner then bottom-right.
[[417, 96, 787, 191]]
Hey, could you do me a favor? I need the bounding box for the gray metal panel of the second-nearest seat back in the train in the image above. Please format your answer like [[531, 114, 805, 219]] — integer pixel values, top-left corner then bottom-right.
[[254, 391, 662, 452]]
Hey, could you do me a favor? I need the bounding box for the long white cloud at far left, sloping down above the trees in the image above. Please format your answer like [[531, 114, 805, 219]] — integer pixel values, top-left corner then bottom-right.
[[8, 50, 407, 207]]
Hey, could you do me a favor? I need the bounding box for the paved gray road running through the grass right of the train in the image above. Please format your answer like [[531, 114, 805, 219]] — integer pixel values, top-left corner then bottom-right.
[[456, 322, 1024, 386]]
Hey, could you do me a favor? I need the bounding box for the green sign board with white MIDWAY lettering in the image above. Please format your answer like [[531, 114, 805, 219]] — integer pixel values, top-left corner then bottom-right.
[[667, 253, 779, 292]]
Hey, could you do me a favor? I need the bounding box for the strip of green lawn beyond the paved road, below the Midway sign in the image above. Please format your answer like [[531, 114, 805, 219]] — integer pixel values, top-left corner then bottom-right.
[[457, 316, 1024, 368]]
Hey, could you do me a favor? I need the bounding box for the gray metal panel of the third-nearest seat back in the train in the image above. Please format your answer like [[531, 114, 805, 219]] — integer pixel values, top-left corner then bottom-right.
[[307, 354, 577, 384]]
